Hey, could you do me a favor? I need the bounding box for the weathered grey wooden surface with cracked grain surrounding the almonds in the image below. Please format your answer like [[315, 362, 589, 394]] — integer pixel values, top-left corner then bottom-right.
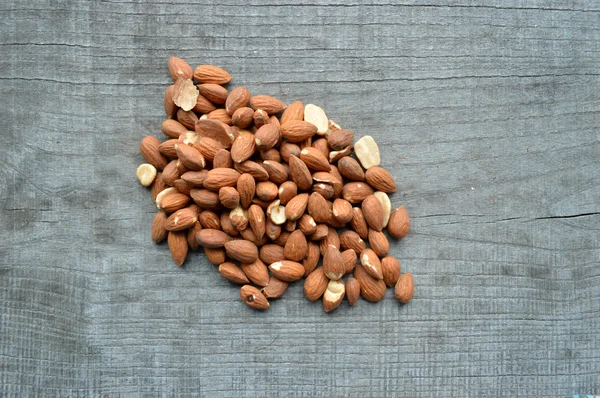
[[0, 0, 600, 397]]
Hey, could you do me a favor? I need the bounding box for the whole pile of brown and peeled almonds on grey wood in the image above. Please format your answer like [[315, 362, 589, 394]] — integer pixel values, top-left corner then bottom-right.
[[137, 57, 413, 312]]
